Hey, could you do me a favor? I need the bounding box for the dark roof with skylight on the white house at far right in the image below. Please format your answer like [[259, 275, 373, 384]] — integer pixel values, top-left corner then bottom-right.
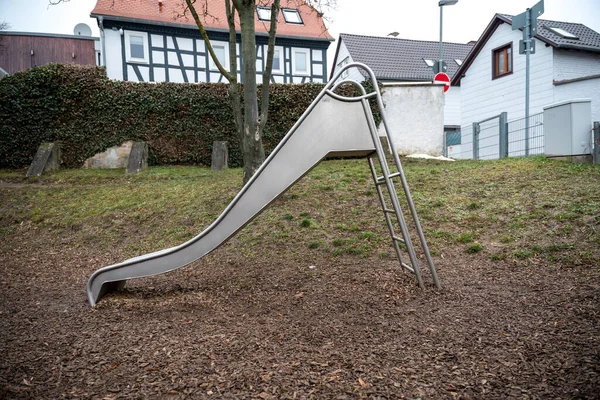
[[452, 14, 600, 86]]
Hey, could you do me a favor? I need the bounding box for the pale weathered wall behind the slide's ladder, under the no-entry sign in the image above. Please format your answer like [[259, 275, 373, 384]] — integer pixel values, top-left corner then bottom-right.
[[379, 84, 445, 156]]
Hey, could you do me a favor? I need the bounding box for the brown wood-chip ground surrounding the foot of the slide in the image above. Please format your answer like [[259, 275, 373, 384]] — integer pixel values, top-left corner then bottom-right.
[[0, 226, 600, 399]]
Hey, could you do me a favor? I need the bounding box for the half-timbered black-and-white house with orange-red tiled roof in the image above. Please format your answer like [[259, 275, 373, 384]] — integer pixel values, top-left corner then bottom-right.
[[91, 0, 333, 83]]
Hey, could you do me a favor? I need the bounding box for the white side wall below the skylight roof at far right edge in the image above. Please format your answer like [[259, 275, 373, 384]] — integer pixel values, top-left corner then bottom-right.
[[554, 49, 600, 81]]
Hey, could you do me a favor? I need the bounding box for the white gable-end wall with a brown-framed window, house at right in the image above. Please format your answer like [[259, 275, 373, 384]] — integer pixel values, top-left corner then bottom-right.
[[460, 24, 554, 158]]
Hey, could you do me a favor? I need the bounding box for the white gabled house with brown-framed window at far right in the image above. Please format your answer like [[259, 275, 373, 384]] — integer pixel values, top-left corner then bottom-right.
[[452, 14, 600, 158]]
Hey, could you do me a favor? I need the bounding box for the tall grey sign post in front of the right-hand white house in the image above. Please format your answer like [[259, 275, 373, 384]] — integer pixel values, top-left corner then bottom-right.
[[512, 0, 544, 156]]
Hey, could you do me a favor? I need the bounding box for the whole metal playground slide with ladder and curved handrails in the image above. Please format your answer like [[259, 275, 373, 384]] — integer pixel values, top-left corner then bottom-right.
[[87, 63, 439, 306]]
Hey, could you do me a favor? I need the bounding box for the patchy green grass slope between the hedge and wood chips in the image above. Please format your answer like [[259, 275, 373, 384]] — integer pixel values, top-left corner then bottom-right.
[[0, 158, 600, 272]]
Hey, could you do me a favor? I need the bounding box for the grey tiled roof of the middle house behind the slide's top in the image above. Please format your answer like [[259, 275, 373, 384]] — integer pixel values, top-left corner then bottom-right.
[[334, 33, 473, 81]]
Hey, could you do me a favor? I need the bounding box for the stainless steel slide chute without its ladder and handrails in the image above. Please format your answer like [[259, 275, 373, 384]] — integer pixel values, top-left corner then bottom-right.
[[87, 90, 375, 306]]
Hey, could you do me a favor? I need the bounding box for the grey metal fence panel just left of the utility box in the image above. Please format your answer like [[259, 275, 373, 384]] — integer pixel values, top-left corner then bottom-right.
[[507, 113, 544, 157]]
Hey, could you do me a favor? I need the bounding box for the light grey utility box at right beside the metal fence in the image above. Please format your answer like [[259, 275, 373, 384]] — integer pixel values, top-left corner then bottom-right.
[[544, 99, 592, 157]]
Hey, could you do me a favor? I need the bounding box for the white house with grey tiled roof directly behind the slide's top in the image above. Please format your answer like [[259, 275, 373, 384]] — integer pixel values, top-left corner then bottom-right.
[[330, 33, 474, 155]]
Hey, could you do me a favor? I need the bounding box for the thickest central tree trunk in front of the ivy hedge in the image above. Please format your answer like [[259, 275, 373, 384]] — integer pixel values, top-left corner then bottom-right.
[[236, 0, 265, 183]]
